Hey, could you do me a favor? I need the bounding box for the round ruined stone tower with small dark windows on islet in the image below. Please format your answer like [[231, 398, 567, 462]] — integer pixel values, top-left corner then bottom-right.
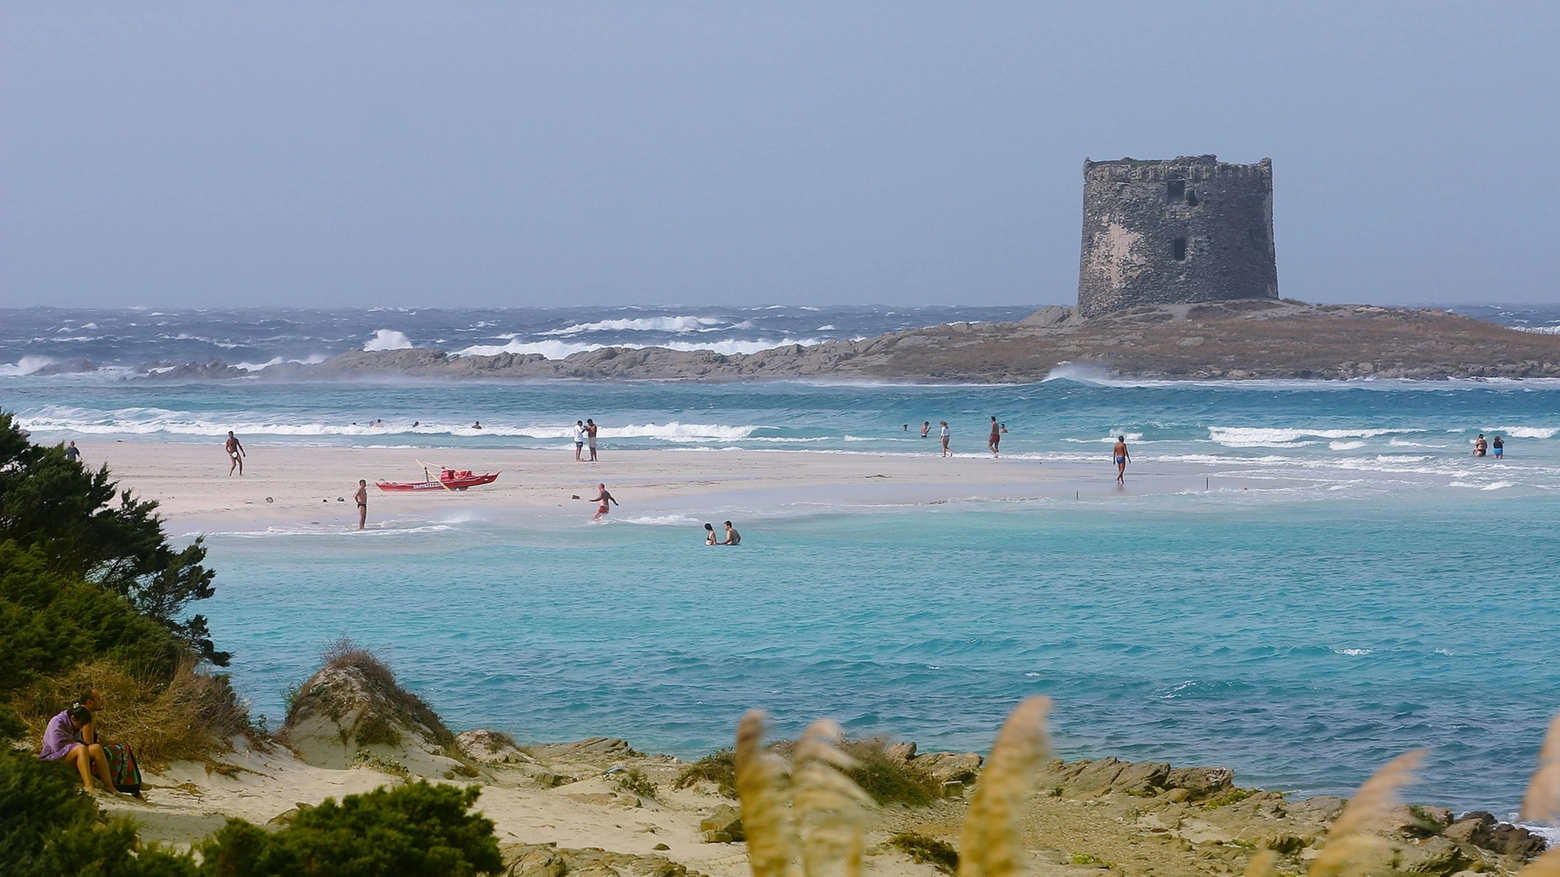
[[1078, 156, 1278, 317]]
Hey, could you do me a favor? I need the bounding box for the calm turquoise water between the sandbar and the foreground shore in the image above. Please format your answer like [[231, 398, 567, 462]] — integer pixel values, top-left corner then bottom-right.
[[204, 492, 1560, 811]]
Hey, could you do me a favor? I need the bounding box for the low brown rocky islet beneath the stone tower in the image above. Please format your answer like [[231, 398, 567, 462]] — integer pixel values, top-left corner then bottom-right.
[[131, 301, 1560, 384]]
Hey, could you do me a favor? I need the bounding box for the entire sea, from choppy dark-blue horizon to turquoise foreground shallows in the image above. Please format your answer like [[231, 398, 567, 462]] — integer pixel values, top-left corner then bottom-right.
[[0, 306, 1560, 818]]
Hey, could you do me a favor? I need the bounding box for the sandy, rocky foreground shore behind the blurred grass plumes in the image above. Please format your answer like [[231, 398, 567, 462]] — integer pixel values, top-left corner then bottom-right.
[[114, 652, 1544, 877]]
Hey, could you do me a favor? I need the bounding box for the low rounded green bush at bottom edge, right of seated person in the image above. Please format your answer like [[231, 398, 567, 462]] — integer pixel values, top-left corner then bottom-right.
[[201, 782, 504, 877]]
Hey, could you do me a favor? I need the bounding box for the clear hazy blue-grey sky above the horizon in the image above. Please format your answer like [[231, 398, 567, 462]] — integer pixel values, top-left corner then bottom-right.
[[0, 0, 1560, 307]]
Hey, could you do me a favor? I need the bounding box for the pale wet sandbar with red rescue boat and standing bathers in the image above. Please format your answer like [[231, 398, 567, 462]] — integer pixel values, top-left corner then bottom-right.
[[83, 437, 1217, 535]]
